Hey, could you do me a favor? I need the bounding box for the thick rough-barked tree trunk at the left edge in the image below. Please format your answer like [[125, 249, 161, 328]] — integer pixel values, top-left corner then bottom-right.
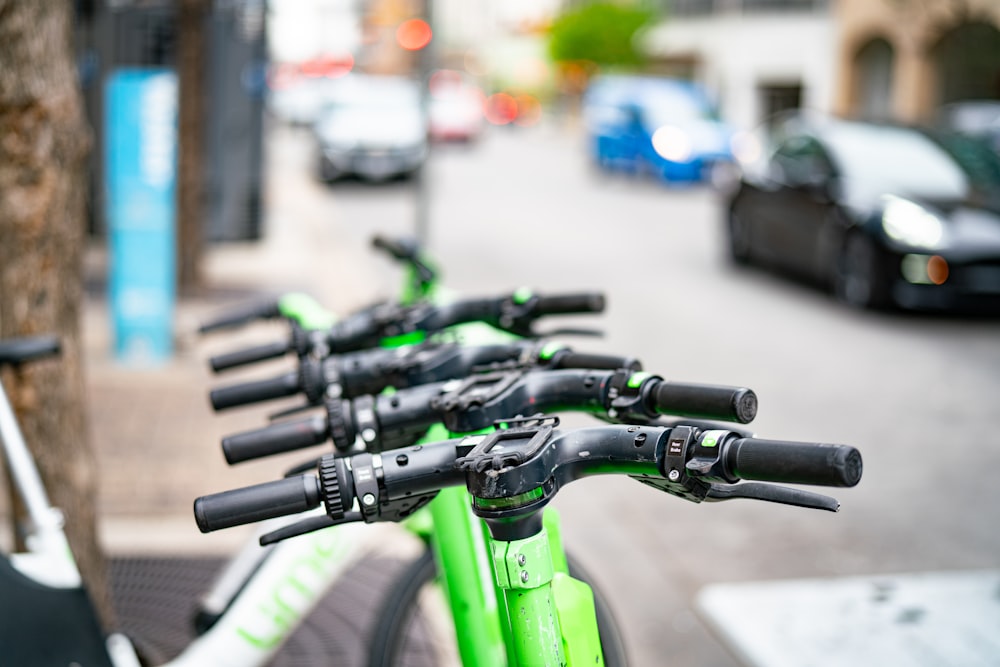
[[0, 0, 113, 627]]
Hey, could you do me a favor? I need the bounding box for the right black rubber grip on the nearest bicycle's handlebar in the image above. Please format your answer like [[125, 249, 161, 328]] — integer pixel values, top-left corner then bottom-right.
[[725, 438, 862, 486]]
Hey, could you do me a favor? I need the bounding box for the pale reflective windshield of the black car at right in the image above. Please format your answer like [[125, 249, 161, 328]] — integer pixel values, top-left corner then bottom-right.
[[826, 123, 969, 200]]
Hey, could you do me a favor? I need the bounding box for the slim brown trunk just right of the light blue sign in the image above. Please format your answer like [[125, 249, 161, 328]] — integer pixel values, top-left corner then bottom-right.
[[177, 0, 211, 295]]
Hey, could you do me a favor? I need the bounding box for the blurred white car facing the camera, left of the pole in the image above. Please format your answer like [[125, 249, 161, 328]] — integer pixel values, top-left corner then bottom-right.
[[313, 74, 428, 182]]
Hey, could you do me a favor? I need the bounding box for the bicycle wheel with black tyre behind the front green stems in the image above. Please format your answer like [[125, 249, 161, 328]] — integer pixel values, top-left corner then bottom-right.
[[369, 549, 628, 667]]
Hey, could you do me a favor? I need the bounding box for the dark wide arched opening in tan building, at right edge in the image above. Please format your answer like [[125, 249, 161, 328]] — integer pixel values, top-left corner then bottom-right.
[[931, 22, 1000, 106]]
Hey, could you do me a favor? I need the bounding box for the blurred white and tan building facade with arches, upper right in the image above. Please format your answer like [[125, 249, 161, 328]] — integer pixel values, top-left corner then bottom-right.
[[643, 0, 1000, 127]]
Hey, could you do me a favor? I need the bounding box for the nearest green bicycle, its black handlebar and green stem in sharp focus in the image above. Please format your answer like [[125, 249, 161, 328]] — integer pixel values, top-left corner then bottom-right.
[[195, 416, 862, 667]]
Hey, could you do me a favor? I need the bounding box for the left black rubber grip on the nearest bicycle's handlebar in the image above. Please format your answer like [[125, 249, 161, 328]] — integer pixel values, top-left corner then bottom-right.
[[194, 475, 320, 533]]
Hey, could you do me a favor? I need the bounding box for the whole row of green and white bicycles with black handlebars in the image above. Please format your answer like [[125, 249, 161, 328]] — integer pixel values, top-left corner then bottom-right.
[[0, 238, 862, 667]]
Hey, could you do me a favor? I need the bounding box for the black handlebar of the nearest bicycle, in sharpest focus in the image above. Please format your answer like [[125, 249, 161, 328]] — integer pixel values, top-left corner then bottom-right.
[[194, 426, 862, 535]]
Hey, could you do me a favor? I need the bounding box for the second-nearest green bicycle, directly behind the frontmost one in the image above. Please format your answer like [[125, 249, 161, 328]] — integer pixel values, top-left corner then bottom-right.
[[199, 360, 756, 665]]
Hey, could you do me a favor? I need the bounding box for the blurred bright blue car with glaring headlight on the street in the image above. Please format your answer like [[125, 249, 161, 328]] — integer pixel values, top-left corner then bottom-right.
[[583, 75, 734, 182]]
